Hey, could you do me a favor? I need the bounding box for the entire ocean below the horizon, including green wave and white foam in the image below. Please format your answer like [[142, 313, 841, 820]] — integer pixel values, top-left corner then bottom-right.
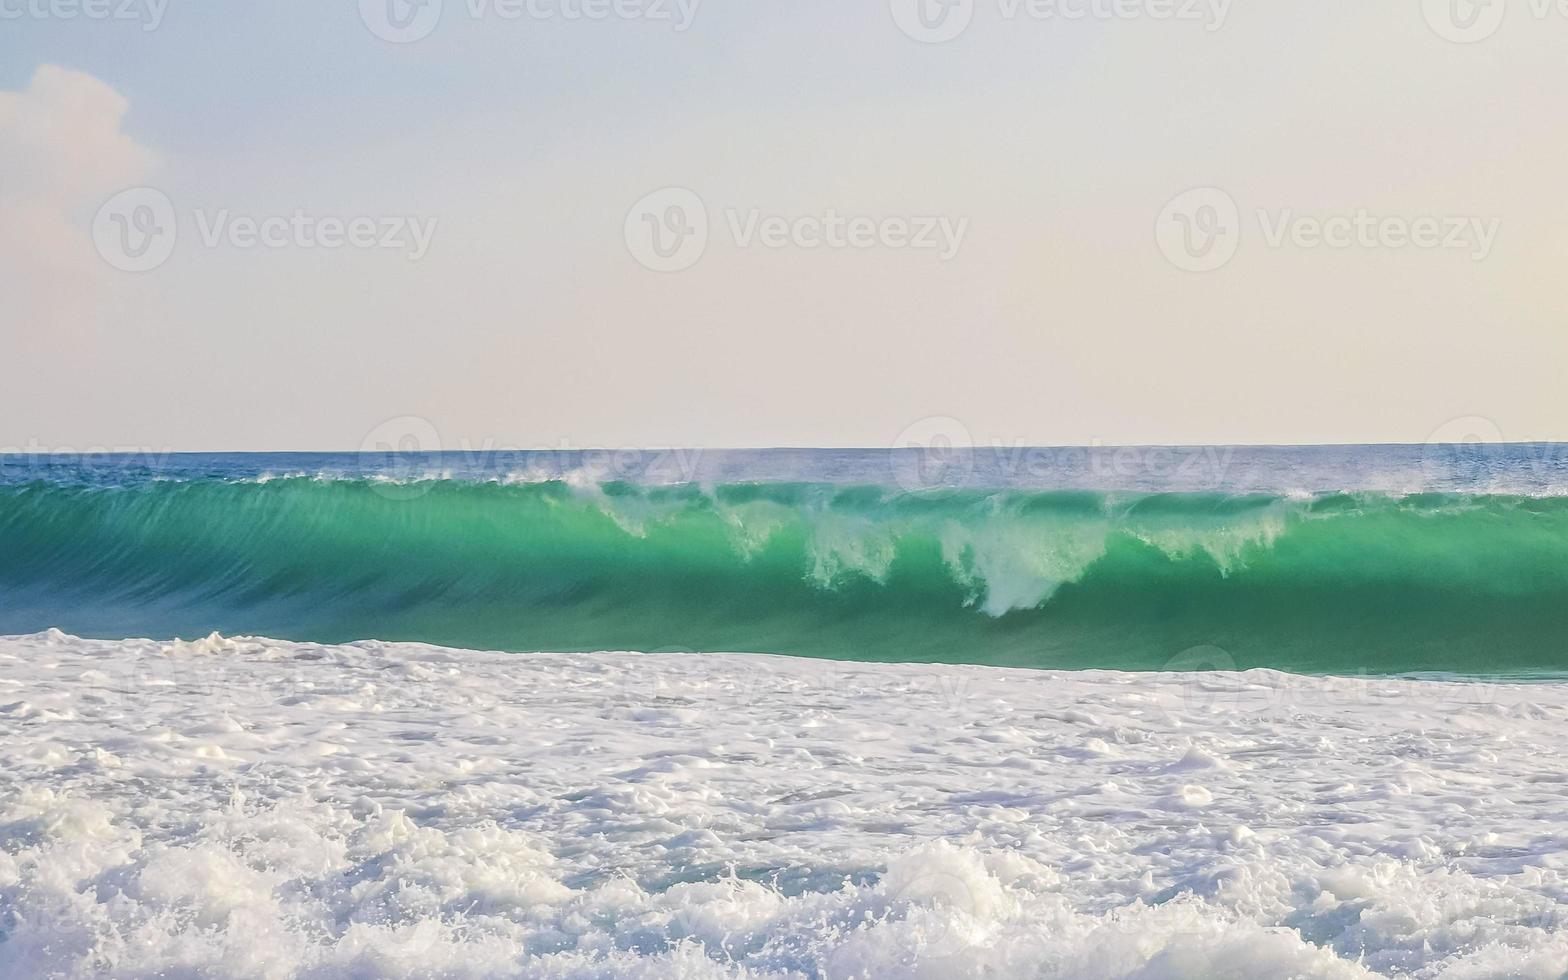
[[0, 445, 1568, 980]]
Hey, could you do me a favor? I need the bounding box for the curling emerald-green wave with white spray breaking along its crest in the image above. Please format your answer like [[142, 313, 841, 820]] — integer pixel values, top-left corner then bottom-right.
[[0, 478, 1568, 674]]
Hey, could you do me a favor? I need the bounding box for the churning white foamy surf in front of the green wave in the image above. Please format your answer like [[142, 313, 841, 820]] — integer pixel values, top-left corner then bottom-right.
[[0, 632, 1568, 978]]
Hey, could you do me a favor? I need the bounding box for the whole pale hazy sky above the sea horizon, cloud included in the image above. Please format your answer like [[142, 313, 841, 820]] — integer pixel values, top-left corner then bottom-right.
[[0, 0, 1568, 452]]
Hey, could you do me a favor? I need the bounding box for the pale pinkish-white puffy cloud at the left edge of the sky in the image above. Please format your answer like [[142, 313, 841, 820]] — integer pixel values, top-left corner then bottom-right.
[[0, 64, 157, 340]]
